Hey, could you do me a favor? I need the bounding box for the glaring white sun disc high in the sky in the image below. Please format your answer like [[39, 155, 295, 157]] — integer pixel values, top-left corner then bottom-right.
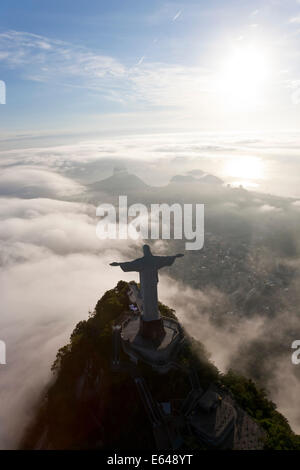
[[217, 45, 270, 109]]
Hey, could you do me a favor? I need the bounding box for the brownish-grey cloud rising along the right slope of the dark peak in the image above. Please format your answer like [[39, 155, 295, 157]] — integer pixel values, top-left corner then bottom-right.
[[159, 276, 300, 433]]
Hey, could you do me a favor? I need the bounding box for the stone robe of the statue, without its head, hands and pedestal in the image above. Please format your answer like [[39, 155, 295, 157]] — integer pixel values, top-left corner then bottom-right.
[[120, 255, 176, 321]]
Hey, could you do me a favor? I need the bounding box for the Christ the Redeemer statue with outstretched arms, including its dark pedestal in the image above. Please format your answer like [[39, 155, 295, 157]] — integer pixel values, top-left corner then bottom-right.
[[110, 245, 184, 339]]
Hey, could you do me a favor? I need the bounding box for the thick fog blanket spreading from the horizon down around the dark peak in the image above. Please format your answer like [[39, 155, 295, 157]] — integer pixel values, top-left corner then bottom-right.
[[0, 135, 300, 448]]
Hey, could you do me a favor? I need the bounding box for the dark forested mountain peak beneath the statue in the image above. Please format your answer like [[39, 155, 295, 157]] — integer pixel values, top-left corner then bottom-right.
[[20, 281, 300, 450]]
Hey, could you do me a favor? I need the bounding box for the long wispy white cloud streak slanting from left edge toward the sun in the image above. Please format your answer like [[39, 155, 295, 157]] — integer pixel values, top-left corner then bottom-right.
[[0, 29, 211, 107]]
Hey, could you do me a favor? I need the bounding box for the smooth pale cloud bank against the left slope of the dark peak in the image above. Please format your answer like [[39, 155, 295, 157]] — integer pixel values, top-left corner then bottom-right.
[[0, 253, 133, 449]]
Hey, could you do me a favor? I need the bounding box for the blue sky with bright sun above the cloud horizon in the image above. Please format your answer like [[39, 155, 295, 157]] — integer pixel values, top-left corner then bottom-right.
[[0, 0, 300, 142]]
